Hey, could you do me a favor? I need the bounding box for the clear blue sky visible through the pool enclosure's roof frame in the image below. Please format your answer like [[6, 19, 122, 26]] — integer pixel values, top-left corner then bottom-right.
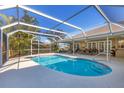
[[0, 5, 124, 42]]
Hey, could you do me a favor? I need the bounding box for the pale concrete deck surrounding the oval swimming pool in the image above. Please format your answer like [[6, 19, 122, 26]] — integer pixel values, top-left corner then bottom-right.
[[0, 54, 124, 88]]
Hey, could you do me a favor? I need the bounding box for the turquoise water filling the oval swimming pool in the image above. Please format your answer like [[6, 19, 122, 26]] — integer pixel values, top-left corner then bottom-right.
[[32, 55, 112, 76]]
